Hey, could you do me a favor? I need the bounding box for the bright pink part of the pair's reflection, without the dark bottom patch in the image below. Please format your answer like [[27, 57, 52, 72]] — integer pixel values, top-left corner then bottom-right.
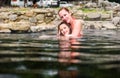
[[58, 37, 80, 63]]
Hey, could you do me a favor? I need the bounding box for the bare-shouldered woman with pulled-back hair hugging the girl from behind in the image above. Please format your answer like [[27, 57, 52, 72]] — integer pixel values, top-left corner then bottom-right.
[[58, 7, 82, 37]]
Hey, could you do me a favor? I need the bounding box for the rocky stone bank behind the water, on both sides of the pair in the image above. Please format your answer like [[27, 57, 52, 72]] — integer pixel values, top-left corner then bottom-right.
[[0, 1, 120, 33]]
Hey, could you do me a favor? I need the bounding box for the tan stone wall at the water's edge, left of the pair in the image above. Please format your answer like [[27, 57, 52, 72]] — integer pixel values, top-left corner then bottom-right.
[[0, 8, 56, 33]]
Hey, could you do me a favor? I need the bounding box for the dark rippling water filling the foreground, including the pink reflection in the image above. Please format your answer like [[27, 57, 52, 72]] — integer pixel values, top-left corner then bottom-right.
[[0, 30, 120, 78]]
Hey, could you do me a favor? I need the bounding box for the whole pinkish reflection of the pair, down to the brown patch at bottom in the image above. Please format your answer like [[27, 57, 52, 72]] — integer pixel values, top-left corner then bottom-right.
[[58, 37, 80, 78]]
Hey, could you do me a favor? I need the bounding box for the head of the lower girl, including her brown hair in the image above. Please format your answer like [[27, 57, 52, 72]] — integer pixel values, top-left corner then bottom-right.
[[58, 22, 72, 36]]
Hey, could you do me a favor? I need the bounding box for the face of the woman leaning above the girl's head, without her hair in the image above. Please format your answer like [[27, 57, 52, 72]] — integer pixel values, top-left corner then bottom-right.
[[59, 9, 71, 23]]
